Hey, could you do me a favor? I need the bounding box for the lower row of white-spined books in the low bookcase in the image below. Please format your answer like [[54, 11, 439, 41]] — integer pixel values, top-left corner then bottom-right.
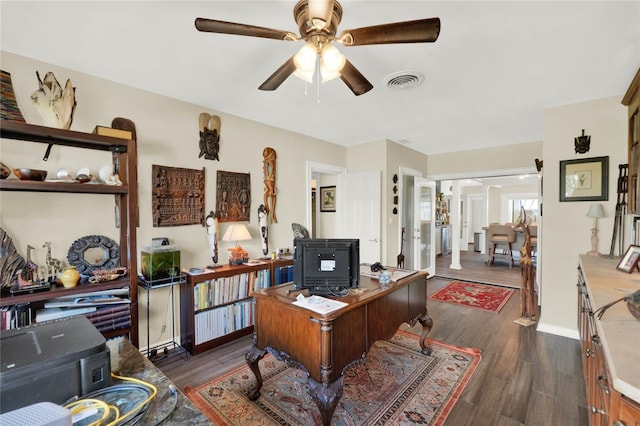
[[195, 300, 254, 345]]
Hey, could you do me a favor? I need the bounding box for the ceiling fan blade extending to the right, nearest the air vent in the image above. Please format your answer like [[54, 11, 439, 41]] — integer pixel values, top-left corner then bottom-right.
[[338, 18, 440, 46]]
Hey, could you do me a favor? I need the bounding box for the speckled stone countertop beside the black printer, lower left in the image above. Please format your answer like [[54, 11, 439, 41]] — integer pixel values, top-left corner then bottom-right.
[[107, 337, 211, 426]]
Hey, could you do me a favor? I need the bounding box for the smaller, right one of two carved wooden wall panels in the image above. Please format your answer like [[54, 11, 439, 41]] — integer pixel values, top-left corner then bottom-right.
[[216, 170, 251, 222]]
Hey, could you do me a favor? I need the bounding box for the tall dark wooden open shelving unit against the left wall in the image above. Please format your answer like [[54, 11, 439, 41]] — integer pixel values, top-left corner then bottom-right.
[[0, 121, 138, 346]]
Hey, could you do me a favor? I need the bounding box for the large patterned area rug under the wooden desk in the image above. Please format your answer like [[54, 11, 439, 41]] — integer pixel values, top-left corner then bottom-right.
[[185, 330, 481, 426]]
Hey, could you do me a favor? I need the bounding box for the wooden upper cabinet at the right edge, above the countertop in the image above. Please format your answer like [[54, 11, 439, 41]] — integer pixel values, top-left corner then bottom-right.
[[622, 69, 640, 214]]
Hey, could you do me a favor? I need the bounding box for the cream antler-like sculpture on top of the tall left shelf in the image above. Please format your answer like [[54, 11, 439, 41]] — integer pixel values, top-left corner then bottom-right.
[[31, 71, 76, 130]]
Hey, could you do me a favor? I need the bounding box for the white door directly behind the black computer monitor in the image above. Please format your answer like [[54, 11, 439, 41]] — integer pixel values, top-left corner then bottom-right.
[[336, 171, 381, 263]]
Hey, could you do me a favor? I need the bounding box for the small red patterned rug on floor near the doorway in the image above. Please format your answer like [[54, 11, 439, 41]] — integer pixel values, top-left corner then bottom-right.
[[429, 281, 515, 312]]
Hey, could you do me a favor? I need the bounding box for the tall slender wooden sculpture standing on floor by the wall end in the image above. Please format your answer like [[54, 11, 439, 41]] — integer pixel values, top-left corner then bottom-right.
[[514, 208, 537, 327]]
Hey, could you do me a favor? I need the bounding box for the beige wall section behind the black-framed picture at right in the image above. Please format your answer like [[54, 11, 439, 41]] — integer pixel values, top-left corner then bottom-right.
[[538, 95, 630, 338]]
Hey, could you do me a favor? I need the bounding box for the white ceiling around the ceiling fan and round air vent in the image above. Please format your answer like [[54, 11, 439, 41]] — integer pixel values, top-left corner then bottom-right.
[[0, 0, 640, 154]]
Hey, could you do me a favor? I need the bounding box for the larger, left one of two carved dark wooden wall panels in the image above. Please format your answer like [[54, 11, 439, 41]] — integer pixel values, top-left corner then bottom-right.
[[151, 164, 205, 227]]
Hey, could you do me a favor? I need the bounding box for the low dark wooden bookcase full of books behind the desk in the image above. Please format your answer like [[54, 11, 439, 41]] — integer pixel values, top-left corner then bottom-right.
[[180, 259, 293, 355]]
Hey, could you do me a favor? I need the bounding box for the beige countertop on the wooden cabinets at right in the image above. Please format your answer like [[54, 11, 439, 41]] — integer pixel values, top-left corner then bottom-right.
[[580, 255, 640, 403]]
